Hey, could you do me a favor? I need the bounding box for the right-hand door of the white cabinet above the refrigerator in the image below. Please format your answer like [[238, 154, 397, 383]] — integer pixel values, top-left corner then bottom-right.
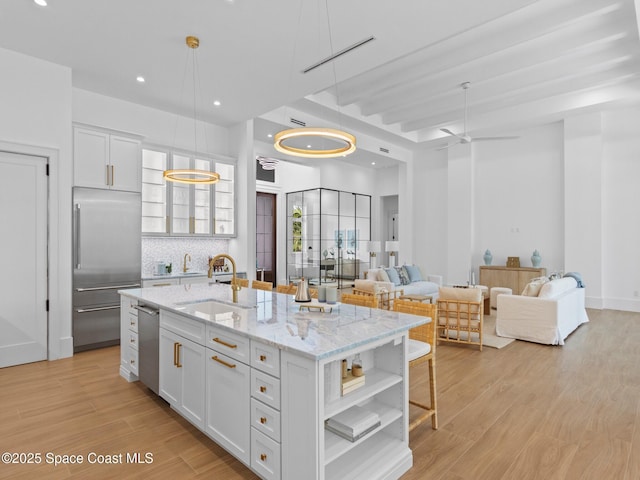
[[109, 135, 142, 192]]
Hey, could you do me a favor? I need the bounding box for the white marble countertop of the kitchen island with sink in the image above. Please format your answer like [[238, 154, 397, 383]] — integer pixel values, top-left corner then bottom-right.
[[119, 283, 430, 360]]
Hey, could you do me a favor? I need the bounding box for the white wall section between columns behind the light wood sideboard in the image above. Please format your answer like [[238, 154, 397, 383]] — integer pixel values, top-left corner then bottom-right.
[[472, 123, 564, 278]]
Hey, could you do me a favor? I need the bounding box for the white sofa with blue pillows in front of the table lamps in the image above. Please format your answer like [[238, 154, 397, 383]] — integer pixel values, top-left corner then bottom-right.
[[353, 266, 442, 303]]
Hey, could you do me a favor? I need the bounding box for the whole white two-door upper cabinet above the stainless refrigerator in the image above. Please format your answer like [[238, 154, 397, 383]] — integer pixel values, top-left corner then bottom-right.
[[73, 127, 142, 192]]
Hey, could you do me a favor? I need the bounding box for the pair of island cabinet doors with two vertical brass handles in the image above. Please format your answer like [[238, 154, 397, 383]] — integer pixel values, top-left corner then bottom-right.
[[159, 328, 206, 430]]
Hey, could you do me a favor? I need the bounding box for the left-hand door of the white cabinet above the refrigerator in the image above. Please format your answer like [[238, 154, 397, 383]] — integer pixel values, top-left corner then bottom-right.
[[73, 128, 110, 188]]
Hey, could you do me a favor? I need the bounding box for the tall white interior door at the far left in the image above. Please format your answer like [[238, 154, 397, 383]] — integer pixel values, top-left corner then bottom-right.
[[0, 151, 48, 367]]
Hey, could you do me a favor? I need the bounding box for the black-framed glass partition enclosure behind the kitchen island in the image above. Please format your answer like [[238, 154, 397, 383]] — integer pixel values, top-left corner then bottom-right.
[[287, 188, 371, 288]]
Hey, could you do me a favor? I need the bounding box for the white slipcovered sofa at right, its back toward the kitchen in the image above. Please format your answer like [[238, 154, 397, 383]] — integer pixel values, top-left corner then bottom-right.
[[496, 277, 589, 345]]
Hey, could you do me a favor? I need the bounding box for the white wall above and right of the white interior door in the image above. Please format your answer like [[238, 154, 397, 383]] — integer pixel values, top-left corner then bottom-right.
[[0, 49, 73, 360]]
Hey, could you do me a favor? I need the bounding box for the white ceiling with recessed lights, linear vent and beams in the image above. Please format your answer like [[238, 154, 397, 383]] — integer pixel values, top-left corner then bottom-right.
[[0, 0, 640, 168]]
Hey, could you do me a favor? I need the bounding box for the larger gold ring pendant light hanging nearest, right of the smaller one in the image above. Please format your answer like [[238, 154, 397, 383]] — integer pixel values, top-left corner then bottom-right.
[[273, 0, 356, 158]]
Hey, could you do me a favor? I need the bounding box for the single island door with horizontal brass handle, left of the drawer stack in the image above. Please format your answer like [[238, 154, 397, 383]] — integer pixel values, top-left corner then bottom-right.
[[205, 348, 251, 465]]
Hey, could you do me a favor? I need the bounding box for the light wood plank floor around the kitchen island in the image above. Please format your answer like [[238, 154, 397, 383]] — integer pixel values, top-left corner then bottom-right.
[[0, 310, 640, 480]]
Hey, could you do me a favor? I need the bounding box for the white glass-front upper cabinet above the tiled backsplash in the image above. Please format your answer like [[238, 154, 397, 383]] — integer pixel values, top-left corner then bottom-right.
[[142, 148, 235, 236]]
